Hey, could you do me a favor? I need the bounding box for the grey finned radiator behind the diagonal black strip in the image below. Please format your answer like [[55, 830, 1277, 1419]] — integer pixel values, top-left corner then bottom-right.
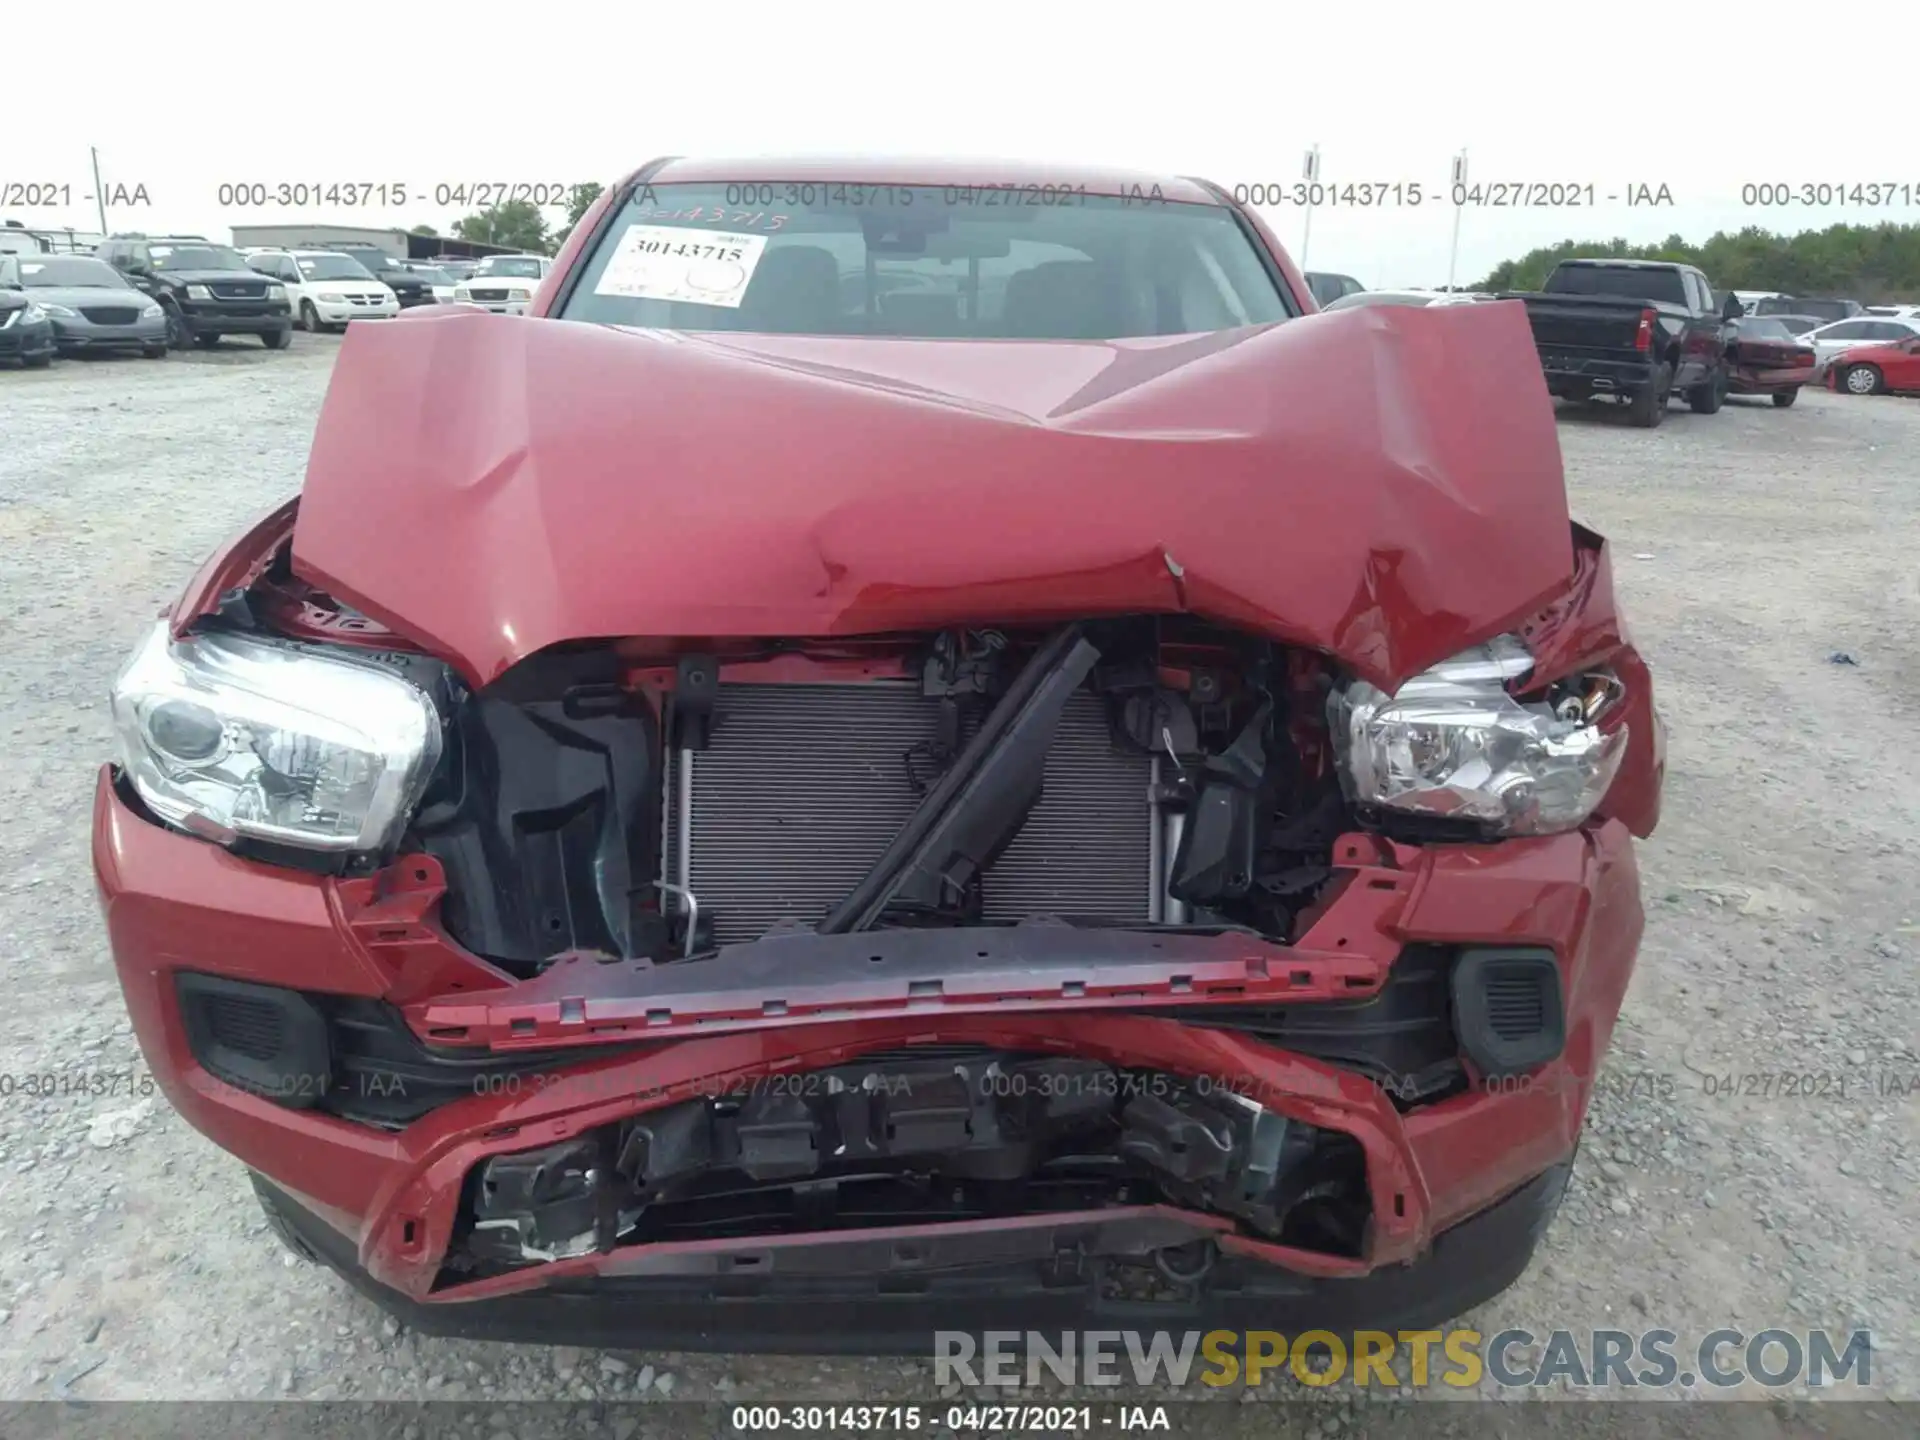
[[660, 680, 1150, 945]]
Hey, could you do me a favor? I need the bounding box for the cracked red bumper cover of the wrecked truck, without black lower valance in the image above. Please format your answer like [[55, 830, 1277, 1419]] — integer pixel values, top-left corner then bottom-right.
[[94, 768, 1642, 1346]]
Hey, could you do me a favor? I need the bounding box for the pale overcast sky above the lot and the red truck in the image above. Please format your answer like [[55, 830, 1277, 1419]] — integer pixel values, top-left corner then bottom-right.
[[15, 0, 1920, 286]]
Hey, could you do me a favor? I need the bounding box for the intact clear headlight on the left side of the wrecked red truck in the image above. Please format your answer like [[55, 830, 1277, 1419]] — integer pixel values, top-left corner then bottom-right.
[[113, 622, 440, 852]]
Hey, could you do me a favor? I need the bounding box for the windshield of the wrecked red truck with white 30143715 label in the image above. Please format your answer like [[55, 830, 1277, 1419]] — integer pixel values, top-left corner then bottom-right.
[[559, 182, 1288, 340]]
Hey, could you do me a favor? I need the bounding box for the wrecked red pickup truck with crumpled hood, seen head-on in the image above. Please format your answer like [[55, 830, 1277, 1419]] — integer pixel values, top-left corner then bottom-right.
[[92, 159, 1663, 1352]]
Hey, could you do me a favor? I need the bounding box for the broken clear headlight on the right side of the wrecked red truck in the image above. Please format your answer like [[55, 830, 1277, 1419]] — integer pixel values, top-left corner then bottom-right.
[[1327, 636, 1628, 835]]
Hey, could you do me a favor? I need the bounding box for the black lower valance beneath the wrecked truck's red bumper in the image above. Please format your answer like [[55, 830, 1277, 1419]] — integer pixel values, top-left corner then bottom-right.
[[253, 1162, 1571, 1356]]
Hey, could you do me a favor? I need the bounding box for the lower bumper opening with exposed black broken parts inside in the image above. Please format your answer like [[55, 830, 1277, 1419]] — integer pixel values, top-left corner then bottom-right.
[[447, 1048, 1369, 1279]]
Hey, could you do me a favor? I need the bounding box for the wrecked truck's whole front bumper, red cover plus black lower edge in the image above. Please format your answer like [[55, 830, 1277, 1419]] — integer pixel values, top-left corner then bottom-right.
[[92, 768, 1644, 1350]]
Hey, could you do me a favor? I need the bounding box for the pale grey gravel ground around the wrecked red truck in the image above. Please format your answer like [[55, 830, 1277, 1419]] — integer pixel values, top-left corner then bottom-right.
[[0, 336, 1920, 1434]]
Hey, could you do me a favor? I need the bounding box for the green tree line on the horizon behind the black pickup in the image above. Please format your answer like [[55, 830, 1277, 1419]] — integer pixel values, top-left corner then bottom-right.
[[1471, 225, 1920, 305]]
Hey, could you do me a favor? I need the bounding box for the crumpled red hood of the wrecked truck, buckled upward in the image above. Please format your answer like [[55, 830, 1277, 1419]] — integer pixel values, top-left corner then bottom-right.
[[294, 303, 1572, 689]]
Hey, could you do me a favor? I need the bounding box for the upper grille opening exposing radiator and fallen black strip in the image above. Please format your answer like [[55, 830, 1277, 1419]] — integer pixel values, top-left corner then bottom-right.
[[395, 618, 1348, 973]]
